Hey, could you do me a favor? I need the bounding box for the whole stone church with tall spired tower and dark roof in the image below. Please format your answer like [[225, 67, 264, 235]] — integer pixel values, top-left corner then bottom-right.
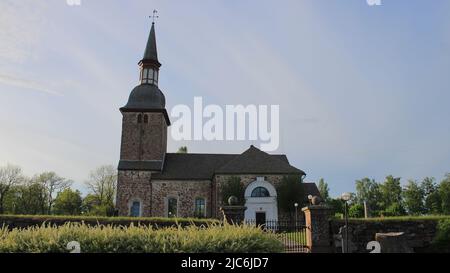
[[116, 24, 319, 222]]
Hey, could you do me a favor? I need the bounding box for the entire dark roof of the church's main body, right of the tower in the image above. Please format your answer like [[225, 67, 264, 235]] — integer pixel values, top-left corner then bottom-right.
[[153, 146, 305, 180]]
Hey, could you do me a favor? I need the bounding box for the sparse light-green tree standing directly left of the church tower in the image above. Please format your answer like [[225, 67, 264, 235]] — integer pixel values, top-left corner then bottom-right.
[[86, 165, 117, 206]]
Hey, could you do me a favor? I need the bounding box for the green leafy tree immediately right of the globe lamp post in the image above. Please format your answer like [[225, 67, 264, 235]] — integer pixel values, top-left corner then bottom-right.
[[356, 177, 381, 215]]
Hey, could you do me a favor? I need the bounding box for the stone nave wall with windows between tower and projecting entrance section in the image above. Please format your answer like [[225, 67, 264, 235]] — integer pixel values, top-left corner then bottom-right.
[[151, 180, 212, 217]]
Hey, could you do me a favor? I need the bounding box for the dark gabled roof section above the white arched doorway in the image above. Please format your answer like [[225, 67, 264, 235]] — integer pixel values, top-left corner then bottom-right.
[[216, 145, 305, 175]]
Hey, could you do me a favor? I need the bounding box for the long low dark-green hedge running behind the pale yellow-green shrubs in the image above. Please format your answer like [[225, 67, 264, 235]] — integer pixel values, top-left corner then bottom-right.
[[0, 215, 219, 229]]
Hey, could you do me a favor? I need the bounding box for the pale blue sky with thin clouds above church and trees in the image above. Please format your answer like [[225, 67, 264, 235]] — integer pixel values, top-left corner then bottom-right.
[[0, 0, 450, 196]]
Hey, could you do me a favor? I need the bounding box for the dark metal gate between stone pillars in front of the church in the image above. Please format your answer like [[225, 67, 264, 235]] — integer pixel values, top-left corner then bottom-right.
[[245, 220, 310, 253]]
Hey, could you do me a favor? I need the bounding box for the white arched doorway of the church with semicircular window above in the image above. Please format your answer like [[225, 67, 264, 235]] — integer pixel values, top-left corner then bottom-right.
[[245, 177, 278, 225]]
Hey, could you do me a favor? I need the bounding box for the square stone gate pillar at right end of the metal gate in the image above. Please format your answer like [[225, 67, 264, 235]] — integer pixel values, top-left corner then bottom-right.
[[302, 205, 333, 253]]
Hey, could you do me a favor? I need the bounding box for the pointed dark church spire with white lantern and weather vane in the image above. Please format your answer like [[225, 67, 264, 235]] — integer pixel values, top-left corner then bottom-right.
[[139, 10, 161, 86]]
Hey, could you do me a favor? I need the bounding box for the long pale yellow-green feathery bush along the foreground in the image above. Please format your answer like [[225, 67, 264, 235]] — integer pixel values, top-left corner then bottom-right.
[[0, 223, 283, 253]]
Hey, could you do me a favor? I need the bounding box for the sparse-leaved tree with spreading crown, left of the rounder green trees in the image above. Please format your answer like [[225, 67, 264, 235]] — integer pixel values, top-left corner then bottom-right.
[[33, 172, 72, 214]]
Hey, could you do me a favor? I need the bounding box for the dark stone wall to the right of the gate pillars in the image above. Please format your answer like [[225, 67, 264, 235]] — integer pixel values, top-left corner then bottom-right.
[[330, 219, 438, 253]]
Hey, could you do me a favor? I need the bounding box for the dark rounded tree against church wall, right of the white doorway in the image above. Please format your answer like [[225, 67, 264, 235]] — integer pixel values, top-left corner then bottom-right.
[[277, 175, 307, 216]]
